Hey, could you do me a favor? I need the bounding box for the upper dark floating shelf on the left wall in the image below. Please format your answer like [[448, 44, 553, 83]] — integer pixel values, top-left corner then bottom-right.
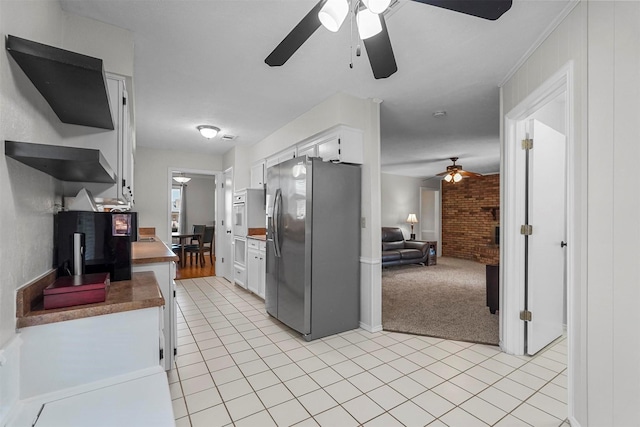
[[6, 35, 114, 130]]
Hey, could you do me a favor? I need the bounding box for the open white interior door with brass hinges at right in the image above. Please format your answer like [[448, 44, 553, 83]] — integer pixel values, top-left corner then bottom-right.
[[525, 120, 566, 355]]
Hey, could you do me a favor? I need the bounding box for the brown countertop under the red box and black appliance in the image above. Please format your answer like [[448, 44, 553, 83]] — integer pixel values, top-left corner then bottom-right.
[[16, 270, 164, 328]]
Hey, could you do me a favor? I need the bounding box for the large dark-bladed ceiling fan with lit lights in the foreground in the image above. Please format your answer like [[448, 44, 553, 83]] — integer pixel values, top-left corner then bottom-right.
[[264, 0, 512, 79]]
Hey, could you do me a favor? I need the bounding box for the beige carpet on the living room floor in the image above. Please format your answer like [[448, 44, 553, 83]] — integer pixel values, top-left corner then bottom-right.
[[382, 257, 499, 345]]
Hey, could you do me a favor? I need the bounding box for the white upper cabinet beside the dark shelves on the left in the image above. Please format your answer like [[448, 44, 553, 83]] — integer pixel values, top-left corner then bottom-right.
[[63, 73, 134, 205]]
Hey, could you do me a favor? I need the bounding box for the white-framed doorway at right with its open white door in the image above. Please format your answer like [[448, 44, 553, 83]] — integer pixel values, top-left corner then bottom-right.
[[500, 63, 579, 417]]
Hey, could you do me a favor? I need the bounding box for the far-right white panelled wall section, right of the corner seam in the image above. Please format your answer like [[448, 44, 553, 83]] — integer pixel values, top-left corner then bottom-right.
[[586, 1, 640, 426]]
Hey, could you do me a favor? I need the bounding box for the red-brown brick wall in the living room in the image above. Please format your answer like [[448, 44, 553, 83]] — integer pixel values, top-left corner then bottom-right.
[[442, 174, 500, 264]]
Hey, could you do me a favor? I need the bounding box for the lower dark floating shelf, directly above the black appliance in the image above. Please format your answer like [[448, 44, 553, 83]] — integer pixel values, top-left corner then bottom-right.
[[4, 141, 116, 184]]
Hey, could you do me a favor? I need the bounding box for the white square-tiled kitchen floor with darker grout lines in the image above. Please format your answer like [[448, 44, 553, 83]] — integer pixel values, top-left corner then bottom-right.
[[168, 277, 569, 427]]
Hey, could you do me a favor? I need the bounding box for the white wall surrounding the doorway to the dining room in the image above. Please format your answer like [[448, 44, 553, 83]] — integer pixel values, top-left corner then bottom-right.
[[134, 147, 222, 242]]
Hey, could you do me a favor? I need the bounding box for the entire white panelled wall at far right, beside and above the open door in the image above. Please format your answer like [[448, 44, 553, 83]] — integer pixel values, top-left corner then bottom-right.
[[502, 1, 640, 426]]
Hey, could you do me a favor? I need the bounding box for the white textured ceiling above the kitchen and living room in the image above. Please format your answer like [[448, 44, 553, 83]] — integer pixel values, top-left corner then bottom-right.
[[61, 0, 569, 177]]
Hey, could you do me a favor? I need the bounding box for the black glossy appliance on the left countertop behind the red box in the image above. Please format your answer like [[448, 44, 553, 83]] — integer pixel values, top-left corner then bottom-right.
[[54, 211, 138, 282]]
